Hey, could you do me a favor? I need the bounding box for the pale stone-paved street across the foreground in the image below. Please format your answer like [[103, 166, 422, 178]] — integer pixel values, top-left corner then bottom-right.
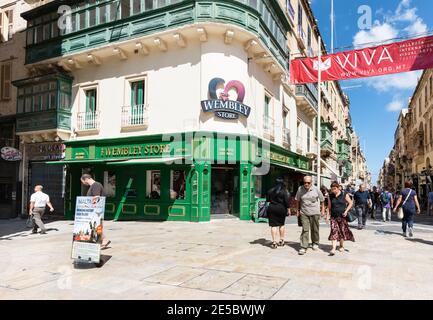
[[0, 218, 433, 300]]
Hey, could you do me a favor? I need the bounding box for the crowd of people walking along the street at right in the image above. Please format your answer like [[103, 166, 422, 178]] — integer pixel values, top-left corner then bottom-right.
[[266, 176, 422, 256]]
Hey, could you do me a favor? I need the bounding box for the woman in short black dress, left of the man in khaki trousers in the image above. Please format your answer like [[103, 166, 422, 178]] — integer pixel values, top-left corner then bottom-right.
[[266, 178, 290, 249]]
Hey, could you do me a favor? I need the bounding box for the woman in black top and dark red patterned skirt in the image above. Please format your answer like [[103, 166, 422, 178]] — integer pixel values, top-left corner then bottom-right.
[[326, 182, 355, 256]]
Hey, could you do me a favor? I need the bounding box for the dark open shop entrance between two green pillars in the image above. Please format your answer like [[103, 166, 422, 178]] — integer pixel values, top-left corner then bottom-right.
[[211, 166, 239, 216]]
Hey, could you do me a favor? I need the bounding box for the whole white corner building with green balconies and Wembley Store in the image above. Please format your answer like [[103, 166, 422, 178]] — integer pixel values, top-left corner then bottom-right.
[[14, 0, 317, 221]]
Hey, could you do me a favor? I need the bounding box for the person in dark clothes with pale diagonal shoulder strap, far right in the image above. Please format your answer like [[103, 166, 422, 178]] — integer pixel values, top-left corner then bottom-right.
[[394, 181, 421, 238]]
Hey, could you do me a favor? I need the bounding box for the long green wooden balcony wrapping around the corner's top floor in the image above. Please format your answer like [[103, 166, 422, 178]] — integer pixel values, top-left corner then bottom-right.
[[22, 0, 290, 69]]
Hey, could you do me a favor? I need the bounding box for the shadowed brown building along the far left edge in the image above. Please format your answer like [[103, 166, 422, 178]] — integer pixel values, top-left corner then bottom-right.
[[0, 0, 45, 219]]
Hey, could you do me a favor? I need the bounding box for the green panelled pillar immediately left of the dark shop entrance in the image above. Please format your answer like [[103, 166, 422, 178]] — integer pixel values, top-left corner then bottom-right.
[[191, 162, 211, 222]]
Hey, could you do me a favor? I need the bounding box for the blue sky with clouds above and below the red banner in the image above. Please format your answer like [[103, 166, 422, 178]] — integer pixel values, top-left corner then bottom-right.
[[311, 0, 433, 183]]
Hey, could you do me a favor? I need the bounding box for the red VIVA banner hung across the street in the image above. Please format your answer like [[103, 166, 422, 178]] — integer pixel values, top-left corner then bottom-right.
[[290, 36, 433, 84]]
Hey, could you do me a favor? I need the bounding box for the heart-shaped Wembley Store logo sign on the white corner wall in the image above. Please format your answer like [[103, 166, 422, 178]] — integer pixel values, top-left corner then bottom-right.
[[201, 78, 251, 120]]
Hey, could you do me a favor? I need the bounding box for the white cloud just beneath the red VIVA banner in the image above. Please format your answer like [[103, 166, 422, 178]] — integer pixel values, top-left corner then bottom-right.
[[363, 71, 422, 92]]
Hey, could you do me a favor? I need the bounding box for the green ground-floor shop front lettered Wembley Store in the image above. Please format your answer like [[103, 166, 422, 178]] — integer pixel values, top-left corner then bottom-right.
[[54, 132, 309, 222]]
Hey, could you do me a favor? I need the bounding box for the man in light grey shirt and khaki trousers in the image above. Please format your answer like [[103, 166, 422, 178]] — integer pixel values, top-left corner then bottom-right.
[[296, 176, 325, 255]]
